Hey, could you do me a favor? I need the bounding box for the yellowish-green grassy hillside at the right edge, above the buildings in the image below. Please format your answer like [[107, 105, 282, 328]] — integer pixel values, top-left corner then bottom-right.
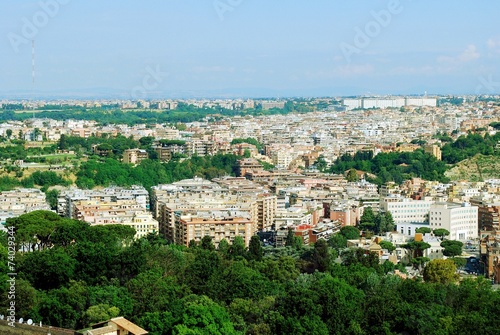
[[445, 154, 500, 181]]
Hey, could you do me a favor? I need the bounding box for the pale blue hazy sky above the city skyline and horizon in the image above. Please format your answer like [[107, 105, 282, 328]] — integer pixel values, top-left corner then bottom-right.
[[0, 0, 500, 99]]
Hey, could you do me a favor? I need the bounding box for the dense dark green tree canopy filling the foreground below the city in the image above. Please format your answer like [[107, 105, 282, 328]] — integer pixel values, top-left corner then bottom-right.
[[0, 211, 500, 335]]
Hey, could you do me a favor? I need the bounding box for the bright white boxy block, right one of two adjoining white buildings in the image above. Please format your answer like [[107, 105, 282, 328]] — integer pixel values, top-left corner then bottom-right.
[[429, 202, 478, 241]]
